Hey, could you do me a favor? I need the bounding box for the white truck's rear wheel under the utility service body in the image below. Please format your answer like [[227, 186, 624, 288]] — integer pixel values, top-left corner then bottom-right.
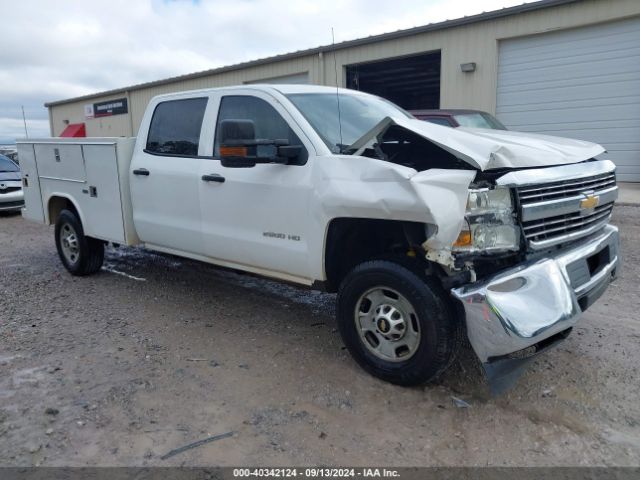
[[55, 210, 104, 276]]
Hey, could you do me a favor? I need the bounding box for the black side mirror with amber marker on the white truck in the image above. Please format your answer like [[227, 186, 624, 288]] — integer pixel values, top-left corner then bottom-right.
[[219, 120, 302, 168]]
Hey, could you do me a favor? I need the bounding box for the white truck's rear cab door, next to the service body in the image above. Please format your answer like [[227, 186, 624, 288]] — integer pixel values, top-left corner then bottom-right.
[[130, 96, 208, 254]]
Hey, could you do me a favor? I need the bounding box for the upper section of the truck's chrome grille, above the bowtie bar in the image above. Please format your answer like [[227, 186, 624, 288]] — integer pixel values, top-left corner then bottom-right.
[[518, 172, 616, 205]]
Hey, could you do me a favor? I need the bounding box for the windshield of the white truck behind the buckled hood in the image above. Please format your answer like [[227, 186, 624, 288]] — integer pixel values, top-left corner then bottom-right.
[[287, 93, 413, 153]]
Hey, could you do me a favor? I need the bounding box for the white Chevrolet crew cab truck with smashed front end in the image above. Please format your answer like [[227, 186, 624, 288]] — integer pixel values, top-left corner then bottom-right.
[[18, 85, 619, 389]]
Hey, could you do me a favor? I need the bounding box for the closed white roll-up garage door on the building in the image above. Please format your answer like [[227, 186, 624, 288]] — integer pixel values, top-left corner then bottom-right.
[[496, 18, 640, 182]]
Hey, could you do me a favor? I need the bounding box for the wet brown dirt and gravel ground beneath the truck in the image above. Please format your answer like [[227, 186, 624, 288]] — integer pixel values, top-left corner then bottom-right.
[[0, 206, 640, 466]]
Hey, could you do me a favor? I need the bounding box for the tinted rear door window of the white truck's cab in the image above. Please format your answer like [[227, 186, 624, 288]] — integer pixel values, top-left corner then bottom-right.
[[145, 98, 208, 157]]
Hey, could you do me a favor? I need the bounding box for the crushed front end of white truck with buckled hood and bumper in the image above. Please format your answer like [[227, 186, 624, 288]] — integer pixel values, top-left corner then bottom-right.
[[344, 118, 619, 393]]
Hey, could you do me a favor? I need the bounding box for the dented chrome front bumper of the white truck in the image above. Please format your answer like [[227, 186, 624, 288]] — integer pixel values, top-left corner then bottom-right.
[[451, 225, 619, 365]]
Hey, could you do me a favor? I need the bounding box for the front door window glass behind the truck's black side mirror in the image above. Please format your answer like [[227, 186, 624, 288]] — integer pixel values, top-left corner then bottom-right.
[[213, 95, 308, 165]]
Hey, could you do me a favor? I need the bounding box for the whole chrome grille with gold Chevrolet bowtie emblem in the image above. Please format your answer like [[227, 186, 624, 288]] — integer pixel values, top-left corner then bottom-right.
[[516, 171, 617, 249]]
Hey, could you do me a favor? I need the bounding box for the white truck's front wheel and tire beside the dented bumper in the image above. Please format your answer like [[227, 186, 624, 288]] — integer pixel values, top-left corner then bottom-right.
[[337, 260, 463, 386]]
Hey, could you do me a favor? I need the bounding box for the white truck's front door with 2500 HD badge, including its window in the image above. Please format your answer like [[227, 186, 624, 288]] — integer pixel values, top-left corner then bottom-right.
[[199, 91, 315, 278]]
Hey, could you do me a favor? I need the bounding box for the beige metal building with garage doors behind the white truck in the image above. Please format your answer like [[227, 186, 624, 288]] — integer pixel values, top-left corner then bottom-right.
[[46, 0, 640, 182]]
